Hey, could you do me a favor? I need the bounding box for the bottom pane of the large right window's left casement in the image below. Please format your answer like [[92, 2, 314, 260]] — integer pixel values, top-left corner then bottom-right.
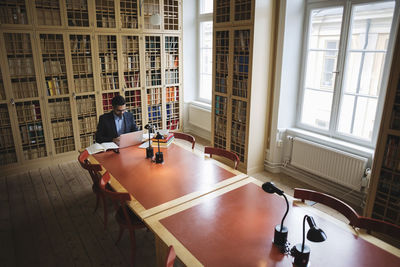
[[301, 89, 333, 130]]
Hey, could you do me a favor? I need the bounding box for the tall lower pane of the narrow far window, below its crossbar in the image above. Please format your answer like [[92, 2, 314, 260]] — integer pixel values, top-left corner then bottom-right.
[[199, 21, 213, 101]]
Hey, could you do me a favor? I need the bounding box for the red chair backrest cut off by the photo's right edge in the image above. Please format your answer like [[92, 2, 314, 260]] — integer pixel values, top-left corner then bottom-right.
[[356, 216, 400, 240]]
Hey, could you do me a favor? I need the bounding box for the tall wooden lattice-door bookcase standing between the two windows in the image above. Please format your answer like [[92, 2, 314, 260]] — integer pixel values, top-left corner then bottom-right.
[[212, 0, 275, 173]]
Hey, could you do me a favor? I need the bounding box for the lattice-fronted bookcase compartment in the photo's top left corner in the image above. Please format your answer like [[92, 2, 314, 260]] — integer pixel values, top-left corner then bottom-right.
[[0, 0, 28, 24]]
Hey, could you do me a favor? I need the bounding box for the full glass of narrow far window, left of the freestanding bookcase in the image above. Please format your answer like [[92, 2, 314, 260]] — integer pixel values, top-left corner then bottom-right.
[[198, 0, 213, 102]]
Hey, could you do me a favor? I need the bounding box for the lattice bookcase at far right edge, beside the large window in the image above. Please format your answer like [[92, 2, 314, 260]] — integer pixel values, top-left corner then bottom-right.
[[364, 29, 400, 229]]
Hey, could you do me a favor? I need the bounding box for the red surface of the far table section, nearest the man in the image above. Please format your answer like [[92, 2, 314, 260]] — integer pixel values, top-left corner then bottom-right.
[[93, 144, 236, 209]]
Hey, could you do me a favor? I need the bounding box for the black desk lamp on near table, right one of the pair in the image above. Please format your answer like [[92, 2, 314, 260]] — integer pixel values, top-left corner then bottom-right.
[[290, 215, 327, 267]]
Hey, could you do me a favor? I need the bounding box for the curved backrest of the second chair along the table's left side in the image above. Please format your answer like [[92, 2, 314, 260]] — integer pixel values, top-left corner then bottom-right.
[[99, 171, 132, 224]]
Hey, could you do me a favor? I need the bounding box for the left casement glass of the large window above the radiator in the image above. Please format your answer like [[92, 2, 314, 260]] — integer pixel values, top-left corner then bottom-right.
[[301, 7, 343, 130]]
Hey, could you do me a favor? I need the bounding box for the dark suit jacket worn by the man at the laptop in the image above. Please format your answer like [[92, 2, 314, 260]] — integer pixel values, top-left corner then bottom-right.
[[96, 111, 138, 143]]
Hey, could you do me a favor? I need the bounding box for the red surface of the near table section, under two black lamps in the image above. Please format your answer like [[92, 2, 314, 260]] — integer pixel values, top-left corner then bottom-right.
[[160, 184, 400, 267]]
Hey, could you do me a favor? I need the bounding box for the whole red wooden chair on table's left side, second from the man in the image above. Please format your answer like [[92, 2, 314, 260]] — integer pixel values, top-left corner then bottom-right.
[[100, 171, 146, 265]]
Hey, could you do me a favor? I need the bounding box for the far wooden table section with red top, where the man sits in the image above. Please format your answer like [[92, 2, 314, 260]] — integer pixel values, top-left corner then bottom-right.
[[89, 143, 247, 219]]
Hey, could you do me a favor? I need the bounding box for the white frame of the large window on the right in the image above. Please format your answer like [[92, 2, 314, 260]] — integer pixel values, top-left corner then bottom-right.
[[296, 0, 400, 148]]
